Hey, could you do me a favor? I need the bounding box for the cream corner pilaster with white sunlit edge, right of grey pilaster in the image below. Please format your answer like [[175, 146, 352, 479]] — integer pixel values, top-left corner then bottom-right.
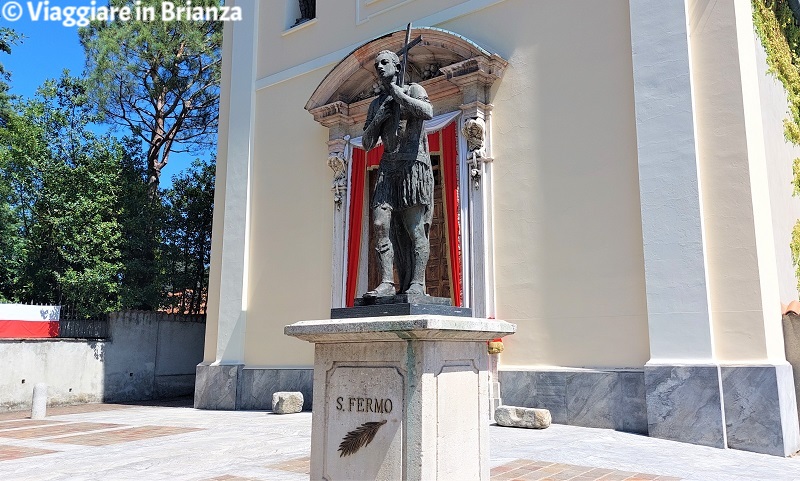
[[690, 0, 783, 362]]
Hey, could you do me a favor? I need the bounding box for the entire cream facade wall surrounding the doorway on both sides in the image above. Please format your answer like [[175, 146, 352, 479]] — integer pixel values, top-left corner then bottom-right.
[[245, 0, 649, 367]]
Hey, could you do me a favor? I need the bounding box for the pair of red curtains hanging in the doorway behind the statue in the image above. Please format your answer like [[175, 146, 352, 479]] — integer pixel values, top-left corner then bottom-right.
[[345, 123, 462, 307]]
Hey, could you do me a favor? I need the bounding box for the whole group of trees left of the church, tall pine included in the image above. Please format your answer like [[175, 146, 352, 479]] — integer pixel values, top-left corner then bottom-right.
[[0, 15, 221, 316]]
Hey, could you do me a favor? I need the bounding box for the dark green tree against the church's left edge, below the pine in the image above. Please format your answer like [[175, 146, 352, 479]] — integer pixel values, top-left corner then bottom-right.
[[163, 160, 215, 314]]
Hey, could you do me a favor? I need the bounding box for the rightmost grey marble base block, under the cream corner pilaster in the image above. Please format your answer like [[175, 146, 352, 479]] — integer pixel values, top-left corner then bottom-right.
[[721, 364, 800, 456]]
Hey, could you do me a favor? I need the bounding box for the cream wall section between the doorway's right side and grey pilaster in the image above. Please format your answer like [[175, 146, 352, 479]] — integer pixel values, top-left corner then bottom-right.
[[441, 0, 649, 367]]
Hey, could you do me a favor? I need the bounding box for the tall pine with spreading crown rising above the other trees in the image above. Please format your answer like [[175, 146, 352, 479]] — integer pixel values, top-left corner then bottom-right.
[[80, 0, 222, 195]]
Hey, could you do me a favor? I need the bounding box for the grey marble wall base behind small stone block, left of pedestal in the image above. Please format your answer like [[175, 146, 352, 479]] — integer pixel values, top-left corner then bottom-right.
[[237, 368, 314, 411]]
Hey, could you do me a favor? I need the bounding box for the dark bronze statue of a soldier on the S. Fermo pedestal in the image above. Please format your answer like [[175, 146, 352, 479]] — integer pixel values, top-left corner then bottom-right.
[[363, 50, 433, 298]]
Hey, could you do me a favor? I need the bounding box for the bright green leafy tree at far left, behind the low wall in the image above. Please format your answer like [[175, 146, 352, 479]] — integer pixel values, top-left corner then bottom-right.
[[0, 73, 126, 315]]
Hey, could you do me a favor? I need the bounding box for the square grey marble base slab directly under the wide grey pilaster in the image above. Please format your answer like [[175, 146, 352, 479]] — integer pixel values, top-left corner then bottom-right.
[[644, 365, 727, 448]]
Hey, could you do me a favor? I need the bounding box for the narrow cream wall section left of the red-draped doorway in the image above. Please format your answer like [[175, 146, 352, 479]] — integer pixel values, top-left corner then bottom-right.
[[245, 72, 334, 367]]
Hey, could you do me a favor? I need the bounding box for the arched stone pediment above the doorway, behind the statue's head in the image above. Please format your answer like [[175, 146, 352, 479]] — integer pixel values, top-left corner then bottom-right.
[[305, 27, 507, 127]]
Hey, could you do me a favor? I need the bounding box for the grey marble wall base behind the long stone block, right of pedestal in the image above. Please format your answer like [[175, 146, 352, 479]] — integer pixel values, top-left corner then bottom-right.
[[498, 369, 647, 434]]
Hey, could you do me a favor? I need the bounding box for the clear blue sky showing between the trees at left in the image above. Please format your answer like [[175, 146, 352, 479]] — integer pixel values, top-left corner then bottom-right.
[[0, 8, 203, 187]]
